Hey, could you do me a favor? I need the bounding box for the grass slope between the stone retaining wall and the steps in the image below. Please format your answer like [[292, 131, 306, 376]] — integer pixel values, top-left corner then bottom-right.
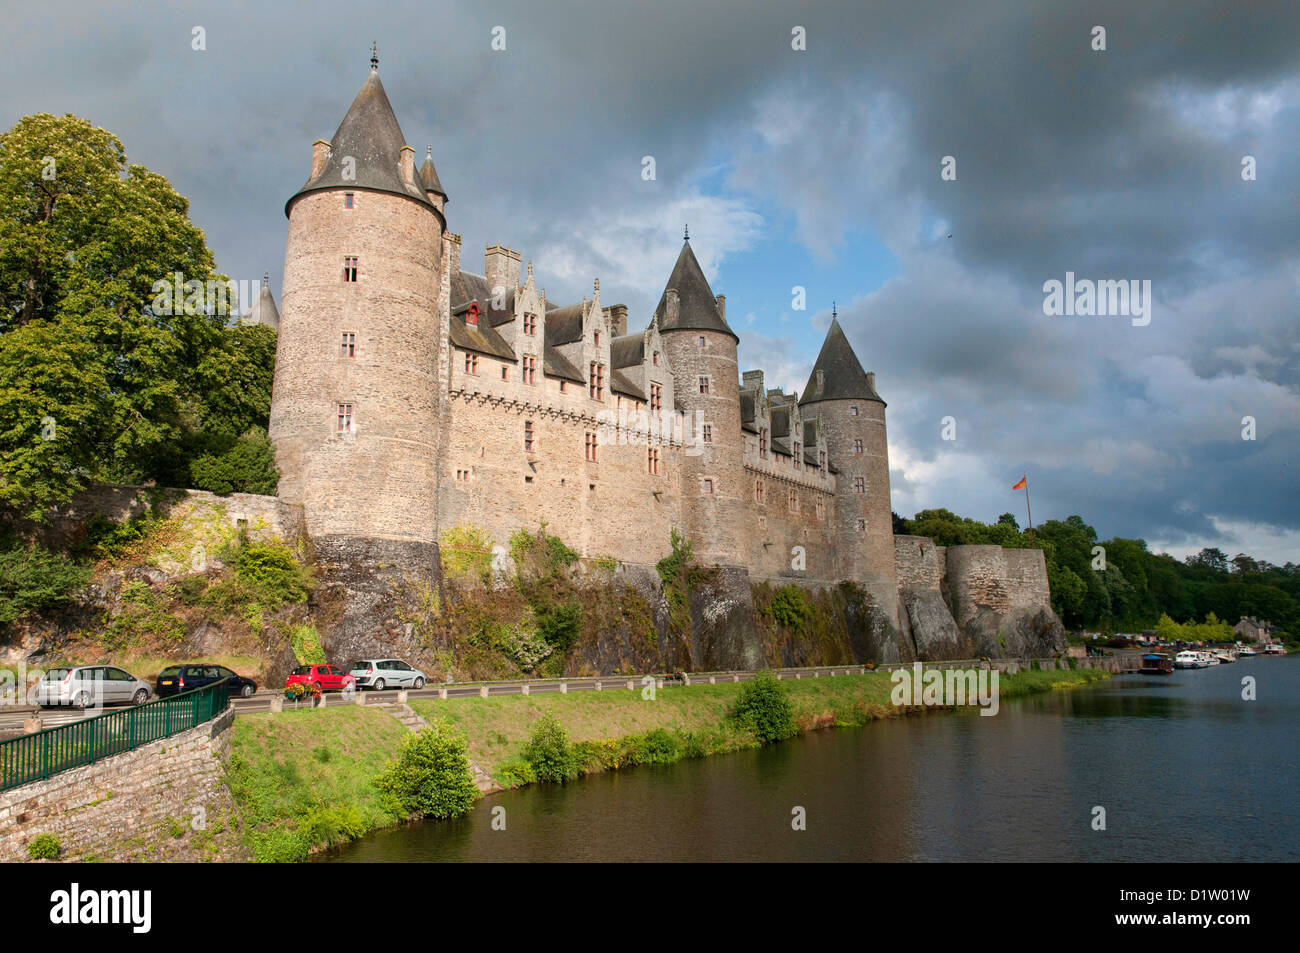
[[228, 705, 408, 861]]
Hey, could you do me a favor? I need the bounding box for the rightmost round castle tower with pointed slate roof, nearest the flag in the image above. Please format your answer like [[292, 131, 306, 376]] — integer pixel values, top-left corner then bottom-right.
[[800, 315, 898, 662]]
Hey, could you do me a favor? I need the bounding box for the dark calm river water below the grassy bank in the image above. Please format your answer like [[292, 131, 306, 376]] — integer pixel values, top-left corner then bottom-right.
[[320, 655, 1300, 862]]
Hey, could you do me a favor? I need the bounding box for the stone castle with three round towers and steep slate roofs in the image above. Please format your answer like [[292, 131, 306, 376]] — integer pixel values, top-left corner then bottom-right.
[[260, 57, 1060, 660]]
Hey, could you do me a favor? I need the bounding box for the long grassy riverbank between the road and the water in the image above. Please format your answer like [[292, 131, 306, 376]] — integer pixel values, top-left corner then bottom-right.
[[220, 668, 1109, 861]]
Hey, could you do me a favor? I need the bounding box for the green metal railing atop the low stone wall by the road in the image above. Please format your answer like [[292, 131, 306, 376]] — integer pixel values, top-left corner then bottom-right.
[[0, 680, 231, 790]]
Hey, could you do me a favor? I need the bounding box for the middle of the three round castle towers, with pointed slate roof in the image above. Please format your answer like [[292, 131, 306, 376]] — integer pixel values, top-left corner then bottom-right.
[[655, 241, 750, 566]]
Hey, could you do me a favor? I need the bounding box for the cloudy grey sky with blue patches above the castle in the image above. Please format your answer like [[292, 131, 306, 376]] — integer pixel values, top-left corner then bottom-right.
[[0, 0, 1300, 564]]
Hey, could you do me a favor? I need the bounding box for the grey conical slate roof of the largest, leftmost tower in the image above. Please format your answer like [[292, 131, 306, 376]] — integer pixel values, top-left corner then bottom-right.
[[285, 69, 442, 215]]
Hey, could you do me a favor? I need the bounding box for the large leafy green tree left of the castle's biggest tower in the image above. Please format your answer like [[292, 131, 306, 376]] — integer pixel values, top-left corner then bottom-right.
[[0, 114, 263, 519]]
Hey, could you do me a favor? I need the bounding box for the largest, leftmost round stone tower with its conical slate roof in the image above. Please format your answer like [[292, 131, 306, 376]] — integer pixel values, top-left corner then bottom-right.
[[270, 57, 446, 567]]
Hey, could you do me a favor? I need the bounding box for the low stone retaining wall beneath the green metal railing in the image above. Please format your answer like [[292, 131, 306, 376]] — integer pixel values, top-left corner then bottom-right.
[[0, 709, 239, 862]]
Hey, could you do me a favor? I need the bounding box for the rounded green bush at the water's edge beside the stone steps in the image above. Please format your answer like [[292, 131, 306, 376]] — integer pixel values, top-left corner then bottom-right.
[[374, 720, 478, 818]]
